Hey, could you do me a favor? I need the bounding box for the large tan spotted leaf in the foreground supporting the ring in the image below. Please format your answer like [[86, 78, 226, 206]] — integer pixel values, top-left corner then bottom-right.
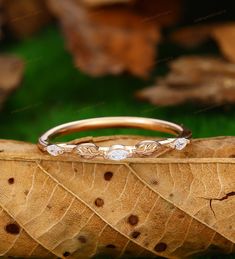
[[0, 136, 235, 258]]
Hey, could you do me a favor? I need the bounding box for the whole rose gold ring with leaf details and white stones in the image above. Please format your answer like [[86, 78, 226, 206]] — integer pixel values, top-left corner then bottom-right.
[[38, 117, 192, 161]]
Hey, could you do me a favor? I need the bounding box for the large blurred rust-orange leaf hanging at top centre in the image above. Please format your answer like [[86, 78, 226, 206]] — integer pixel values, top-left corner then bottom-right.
[[49, 0, 160, 77]]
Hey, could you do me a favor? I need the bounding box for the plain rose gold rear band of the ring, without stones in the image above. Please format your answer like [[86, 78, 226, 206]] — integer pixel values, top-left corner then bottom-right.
[[39, 117, 191, 148]]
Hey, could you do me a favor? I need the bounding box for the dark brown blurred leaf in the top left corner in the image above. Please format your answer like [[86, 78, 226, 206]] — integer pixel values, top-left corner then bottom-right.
[[4, 0, 51, 38]]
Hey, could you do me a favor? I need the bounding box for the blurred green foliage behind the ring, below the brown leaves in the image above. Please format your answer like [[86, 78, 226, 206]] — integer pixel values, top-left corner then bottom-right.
[[0, 27, 235, 142]]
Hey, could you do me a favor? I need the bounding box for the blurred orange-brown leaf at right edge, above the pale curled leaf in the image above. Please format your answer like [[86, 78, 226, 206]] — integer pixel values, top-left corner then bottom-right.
[[171, 23, 235, 63]]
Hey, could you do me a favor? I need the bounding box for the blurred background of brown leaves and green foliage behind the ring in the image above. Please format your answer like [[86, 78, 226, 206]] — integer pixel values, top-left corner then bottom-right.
[[0, 0, 235, 143]]
